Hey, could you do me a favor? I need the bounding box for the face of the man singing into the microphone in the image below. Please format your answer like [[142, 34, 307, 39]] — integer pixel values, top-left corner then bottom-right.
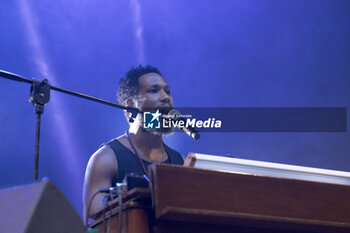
[[135, 73, 174, 111]]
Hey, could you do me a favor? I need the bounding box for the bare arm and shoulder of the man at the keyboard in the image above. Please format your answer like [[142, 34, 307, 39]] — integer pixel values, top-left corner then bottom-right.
[[83, 146, 118, 224]]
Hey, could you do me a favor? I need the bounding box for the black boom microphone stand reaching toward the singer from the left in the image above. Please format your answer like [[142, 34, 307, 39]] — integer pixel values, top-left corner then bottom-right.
[[0, 70, 140, 180]]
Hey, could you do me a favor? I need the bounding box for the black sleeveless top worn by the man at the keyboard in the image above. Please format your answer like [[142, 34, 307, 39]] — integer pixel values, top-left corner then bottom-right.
[[104, 139, 184, 186]]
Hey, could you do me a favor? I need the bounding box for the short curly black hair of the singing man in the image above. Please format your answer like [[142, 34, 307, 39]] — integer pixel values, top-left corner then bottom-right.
[[117, 65, 162, 105]]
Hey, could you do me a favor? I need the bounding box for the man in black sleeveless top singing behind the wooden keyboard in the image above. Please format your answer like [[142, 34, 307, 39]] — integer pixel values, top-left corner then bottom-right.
[[83, 65, 184, 222]]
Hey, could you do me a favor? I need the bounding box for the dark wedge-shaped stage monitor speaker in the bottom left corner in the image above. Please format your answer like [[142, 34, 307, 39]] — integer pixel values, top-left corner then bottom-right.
[[0, 179, 86, 233]]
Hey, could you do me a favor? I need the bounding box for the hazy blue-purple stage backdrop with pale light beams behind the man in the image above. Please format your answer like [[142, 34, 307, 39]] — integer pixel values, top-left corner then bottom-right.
[[0, 0, 350, 218]]
